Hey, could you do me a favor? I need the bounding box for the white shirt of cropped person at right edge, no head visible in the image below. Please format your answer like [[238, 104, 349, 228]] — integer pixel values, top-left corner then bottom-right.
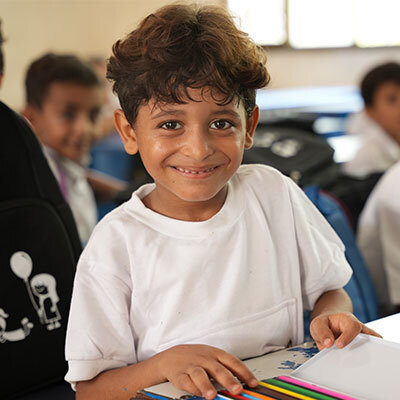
[[357, 162, 400, 305]]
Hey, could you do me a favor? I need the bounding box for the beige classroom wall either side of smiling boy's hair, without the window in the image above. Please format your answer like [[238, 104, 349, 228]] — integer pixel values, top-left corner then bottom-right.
[[0, 0, 400, 110]]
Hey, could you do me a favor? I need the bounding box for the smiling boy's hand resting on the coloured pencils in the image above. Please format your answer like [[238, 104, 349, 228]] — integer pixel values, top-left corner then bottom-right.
[[155, 344, 257, 399]]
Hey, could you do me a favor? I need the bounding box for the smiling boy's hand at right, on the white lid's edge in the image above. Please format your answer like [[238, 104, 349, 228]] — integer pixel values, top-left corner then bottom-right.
[[310, 312, 382, 350]]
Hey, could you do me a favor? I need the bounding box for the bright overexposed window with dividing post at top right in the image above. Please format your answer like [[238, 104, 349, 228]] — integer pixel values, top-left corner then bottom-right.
[[227, 0, 400, 49]]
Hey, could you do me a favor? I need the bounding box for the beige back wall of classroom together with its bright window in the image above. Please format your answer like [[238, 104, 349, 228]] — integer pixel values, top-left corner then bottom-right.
[[0, 0, 400, 110]]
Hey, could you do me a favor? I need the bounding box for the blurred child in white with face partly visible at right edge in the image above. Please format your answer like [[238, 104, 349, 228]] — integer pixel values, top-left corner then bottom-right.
[[344, 62, 400, 177]]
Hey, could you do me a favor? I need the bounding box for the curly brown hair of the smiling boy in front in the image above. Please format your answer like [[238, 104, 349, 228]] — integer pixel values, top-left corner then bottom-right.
[[107, 4, 269, 125]]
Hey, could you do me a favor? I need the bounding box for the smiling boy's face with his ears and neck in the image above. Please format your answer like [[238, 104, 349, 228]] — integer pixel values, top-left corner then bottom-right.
[[115, 89, 258, 219]]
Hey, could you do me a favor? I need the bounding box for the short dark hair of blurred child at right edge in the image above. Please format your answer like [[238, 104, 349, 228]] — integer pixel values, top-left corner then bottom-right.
[[360, 62, 400, 106]]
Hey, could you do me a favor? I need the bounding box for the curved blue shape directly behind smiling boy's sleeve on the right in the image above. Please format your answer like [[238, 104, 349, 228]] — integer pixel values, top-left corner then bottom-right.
[[304, 185, 378, 322]]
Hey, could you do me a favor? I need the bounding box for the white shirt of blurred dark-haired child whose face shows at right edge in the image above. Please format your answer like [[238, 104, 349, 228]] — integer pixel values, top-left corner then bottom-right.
[[343, 111, 400, 177]]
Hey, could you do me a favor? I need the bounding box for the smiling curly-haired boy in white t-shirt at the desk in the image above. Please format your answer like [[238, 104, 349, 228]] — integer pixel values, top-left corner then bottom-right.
[[66, 4, 376, 400]]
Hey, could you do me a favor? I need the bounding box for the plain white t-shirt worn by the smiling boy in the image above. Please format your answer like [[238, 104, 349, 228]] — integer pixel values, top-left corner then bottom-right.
[[66, 165, 351, 383]]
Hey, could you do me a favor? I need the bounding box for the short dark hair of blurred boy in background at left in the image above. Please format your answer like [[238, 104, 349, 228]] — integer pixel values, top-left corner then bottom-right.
[[25, 53, 101, 108]]
